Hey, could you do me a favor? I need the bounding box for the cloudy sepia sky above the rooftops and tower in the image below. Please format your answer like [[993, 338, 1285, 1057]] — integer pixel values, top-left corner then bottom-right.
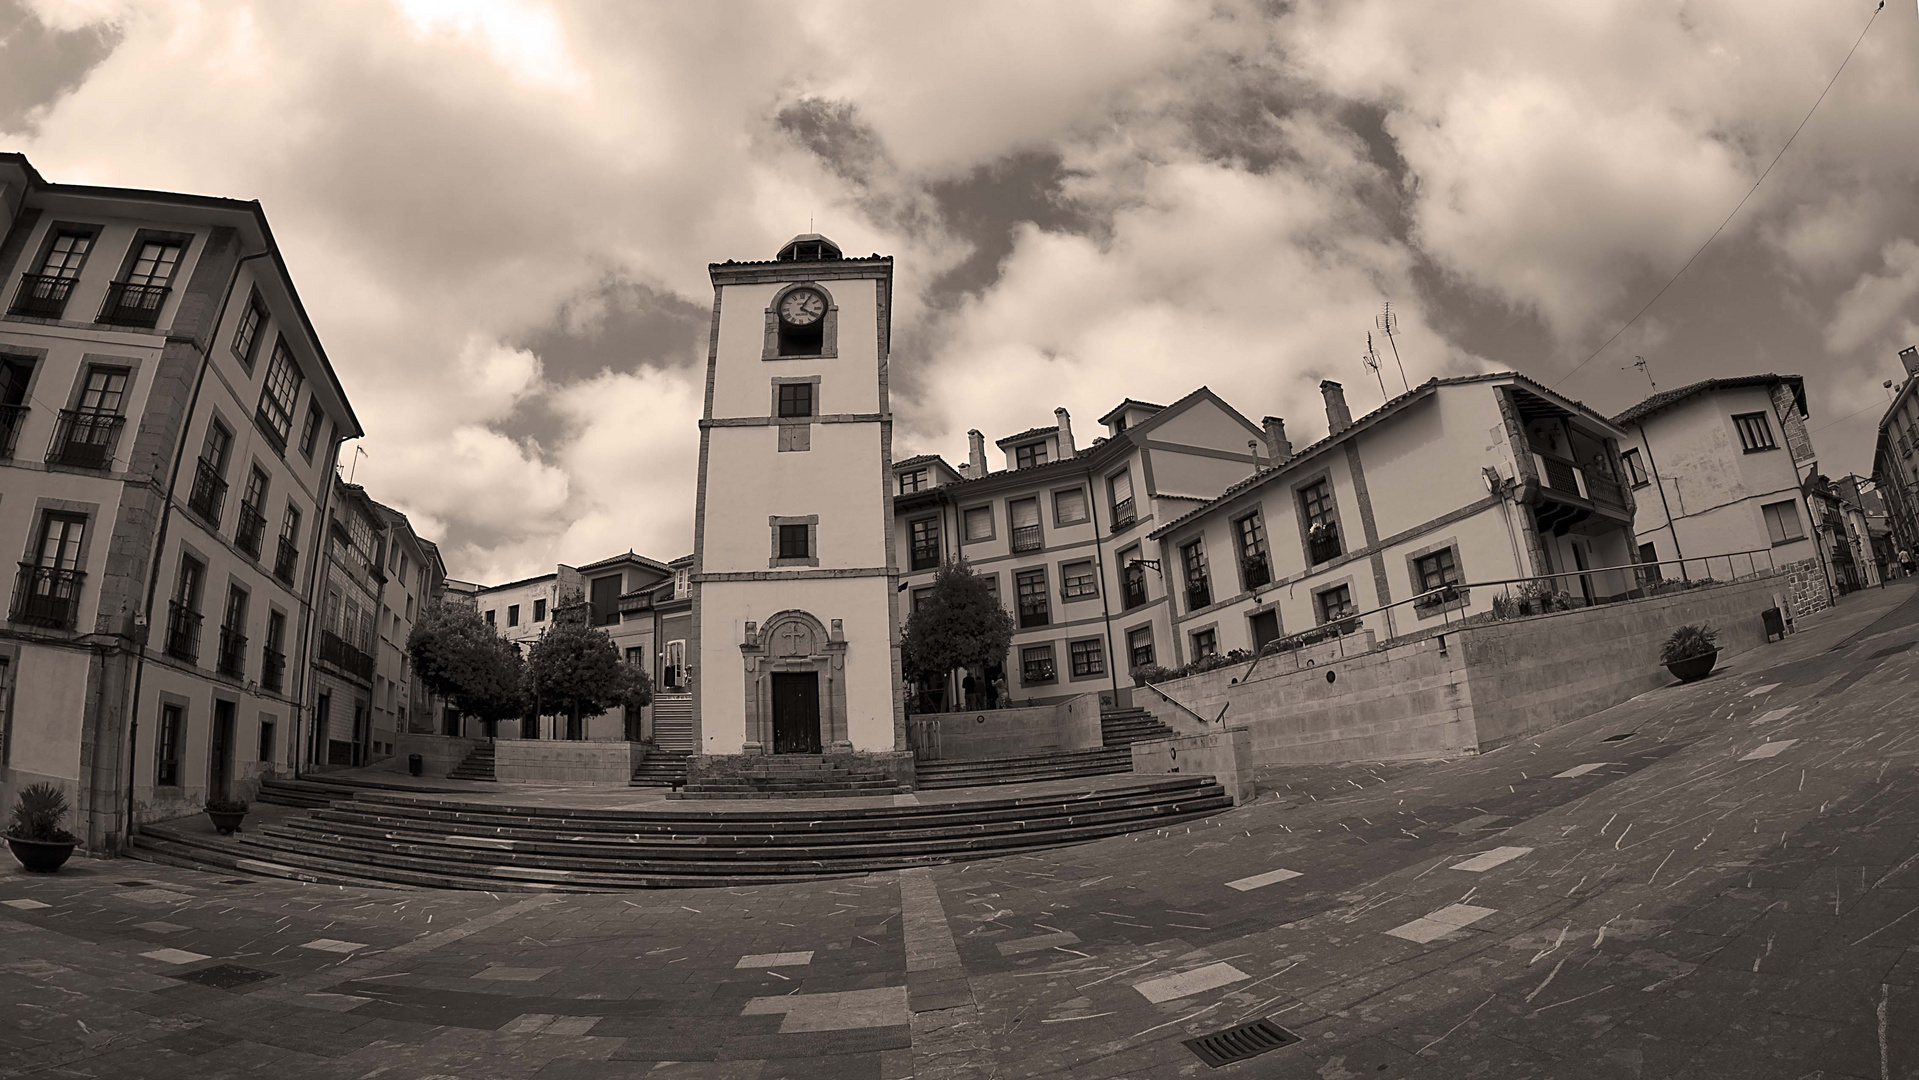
[[0, 0, 1919, 581]]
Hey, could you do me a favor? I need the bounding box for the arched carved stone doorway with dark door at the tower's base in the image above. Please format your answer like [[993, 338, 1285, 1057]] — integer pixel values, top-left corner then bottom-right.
[[739, 610, 852, 754]]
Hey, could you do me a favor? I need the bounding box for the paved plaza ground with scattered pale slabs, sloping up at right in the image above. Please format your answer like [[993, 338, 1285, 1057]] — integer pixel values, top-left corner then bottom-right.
[[0, 587, 1919, 1080]]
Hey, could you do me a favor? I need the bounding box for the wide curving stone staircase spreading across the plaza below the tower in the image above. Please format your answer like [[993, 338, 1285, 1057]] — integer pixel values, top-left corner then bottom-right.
[[134, 777, 1232, 892]]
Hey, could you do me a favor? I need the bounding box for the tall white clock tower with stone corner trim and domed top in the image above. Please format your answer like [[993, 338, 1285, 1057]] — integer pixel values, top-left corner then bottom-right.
[[687, 234, 906, 754]]
